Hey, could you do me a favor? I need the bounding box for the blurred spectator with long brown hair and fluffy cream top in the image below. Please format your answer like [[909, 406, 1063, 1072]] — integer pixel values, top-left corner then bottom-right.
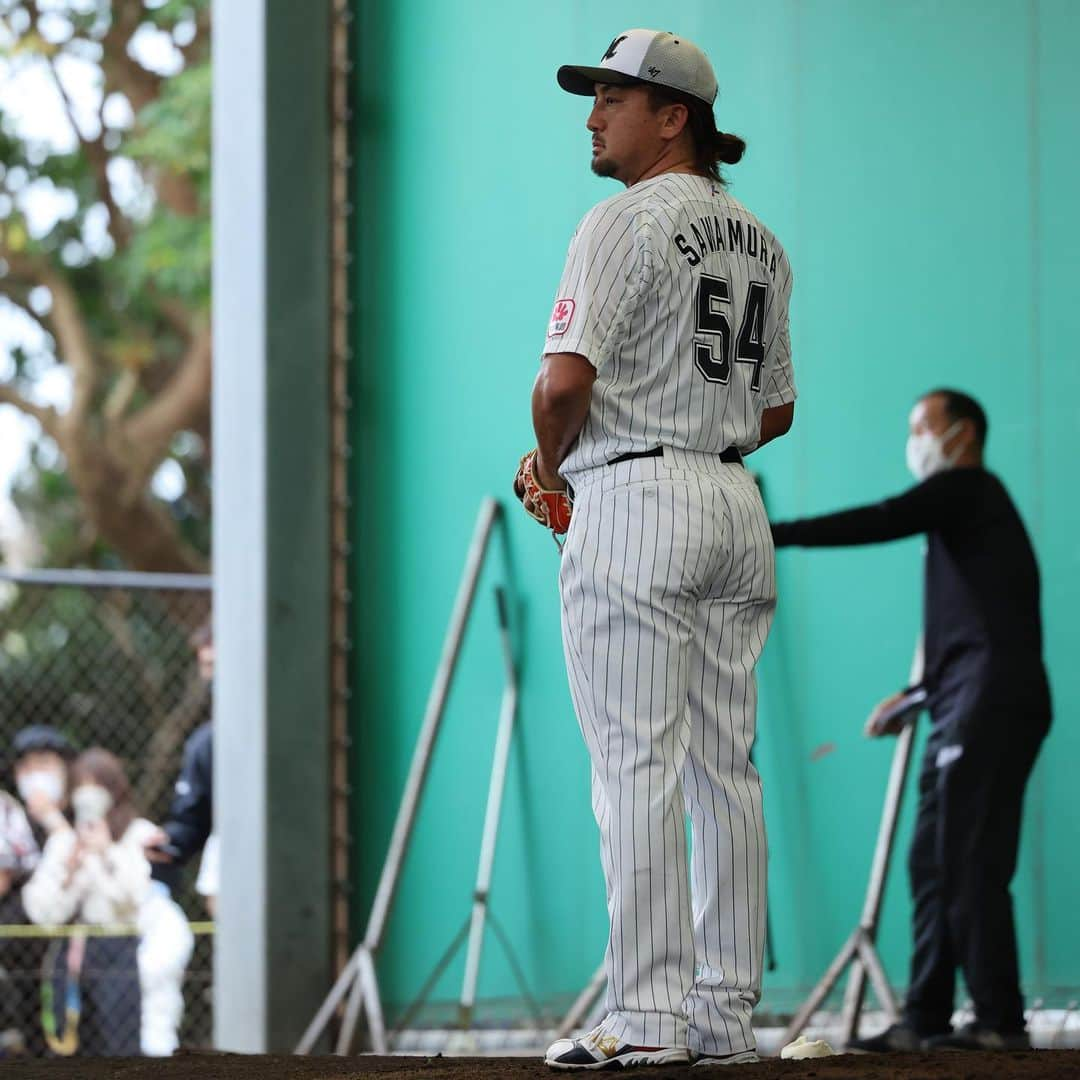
[[23, 750, 153, 1057]]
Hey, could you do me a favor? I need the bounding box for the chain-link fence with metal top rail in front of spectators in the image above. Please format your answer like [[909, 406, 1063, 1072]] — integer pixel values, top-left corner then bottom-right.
[[0, 570, 213, 1059]]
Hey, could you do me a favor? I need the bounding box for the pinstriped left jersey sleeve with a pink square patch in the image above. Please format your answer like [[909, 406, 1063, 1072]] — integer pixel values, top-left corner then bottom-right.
[[543, 204, 651, 370]]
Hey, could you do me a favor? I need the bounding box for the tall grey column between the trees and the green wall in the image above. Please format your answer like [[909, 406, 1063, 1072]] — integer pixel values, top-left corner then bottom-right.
[[213, 0, 330, 1053]]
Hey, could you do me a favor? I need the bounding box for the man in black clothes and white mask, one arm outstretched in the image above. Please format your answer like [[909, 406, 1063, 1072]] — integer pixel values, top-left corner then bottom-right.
[[772, 390, 1051, 1052]]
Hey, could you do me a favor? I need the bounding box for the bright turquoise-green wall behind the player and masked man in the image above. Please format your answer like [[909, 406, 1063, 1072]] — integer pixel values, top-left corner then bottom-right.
[[353, 0, 1080, 1017]]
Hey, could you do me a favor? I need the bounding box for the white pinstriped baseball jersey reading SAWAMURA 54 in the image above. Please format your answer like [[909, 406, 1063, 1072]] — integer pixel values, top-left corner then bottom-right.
[[544, 173, 796, 477]]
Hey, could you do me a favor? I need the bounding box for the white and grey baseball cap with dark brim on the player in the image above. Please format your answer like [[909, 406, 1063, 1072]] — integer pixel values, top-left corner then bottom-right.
[[557, 30, 716, 105]]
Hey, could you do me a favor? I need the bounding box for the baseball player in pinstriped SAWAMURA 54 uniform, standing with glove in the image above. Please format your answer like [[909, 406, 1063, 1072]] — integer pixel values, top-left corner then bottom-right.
[[515, 29, 795, 1069]]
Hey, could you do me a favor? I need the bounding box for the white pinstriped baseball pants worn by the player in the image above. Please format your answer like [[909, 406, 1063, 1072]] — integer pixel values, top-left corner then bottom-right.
[[559, 448, 775, 1054]]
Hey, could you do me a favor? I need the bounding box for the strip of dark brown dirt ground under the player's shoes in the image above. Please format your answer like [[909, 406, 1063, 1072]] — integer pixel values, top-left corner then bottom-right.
[[0, 1050, 1080, 1080]]
